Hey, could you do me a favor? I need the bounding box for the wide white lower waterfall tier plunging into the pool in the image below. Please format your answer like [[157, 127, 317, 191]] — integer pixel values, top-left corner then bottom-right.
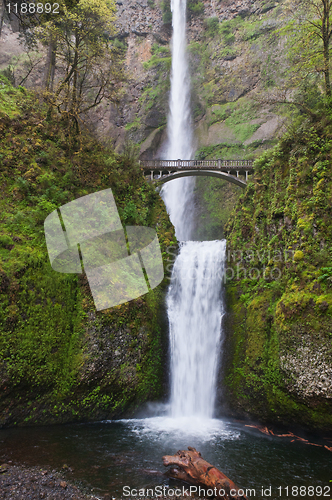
[[167, 240, 226, 418]]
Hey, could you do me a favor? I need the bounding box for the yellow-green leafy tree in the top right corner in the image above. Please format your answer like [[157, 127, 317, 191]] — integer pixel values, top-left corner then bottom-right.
[[256, 0, 332, 115]]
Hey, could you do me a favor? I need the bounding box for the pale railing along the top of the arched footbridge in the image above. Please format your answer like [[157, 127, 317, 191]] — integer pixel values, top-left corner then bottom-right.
[[140, 159, 253, 170]]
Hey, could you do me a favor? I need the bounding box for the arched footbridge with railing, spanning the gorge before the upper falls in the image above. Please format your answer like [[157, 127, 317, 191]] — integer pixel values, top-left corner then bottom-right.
[[140, 159, 254, 188]]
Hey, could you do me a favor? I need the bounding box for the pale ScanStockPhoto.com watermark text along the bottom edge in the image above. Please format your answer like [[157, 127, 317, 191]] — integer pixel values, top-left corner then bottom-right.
[[122, 485, 256, 498]]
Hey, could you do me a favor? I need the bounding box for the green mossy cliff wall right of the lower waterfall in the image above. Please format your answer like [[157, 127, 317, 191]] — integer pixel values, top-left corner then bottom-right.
[[225, 108, 332, 429]]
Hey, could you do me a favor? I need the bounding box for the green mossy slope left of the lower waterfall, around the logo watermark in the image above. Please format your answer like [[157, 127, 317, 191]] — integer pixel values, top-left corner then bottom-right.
[[0, 82, 174, 425]]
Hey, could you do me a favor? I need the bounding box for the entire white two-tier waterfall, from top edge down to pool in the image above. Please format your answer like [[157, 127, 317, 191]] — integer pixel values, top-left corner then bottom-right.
[[161, 0, 226, 425]]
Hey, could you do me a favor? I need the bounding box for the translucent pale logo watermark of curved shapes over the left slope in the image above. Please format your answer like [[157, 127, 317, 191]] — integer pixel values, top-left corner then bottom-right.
[[44, 189, 164, 311]]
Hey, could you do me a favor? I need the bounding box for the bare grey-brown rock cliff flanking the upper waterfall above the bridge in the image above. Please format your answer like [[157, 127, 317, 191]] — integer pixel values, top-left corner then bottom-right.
[[106, 0, 284, 159]]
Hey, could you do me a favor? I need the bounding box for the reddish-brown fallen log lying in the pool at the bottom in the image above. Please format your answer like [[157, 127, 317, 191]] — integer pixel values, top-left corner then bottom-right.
[[163, 446, 248, 500]]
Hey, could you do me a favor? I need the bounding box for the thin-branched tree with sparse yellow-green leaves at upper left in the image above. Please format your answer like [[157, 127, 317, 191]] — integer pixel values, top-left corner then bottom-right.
[[34, 0, 123, 131]]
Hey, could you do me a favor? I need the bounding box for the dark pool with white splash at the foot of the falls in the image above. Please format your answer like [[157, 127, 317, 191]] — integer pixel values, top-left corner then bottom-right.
[[0, 417, 332, 500]]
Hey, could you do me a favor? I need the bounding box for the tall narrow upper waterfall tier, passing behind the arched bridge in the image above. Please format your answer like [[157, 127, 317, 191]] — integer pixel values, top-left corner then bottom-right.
[[161, 0, 195, 241]]
